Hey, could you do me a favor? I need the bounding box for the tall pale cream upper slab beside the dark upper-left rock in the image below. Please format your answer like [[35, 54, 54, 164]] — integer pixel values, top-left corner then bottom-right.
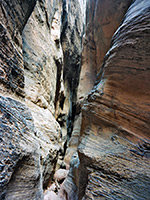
[[23, 0, 63, 114]]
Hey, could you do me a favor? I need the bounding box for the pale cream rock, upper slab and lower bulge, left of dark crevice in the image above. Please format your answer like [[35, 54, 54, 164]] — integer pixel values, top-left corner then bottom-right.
[[23, 0, 63, 187]]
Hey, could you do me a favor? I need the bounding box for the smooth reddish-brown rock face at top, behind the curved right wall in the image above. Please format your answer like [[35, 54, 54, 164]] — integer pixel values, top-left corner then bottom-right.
[[78, 0, 132, 99]]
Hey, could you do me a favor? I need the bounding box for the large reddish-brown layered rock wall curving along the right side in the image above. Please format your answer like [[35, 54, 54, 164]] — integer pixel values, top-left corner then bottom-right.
[[76, 0, 150, 200]]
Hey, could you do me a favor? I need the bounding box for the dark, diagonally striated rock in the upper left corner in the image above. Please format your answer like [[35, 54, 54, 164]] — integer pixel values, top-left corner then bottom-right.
[[0, 0, 36, 96]]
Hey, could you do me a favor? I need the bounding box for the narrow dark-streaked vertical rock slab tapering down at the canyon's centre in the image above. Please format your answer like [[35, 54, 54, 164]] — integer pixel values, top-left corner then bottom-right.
[[61, 0, 84, 154]]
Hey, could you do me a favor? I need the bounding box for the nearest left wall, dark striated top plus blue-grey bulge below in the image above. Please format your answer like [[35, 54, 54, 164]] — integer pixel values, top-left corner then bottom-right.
[[0, 0, 43, 199]]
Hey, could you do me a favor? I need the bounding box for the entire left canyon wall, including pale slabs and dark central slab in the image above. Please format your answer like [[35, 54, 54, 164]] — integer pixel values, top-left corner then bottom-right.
[[0, 0, 84, 200]]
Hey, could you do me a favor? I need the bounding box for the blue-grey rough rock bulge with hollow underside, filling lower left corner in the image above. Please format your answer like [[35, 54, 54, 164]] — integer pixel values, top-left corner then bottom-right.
[[0, 96, 43, 200]]
